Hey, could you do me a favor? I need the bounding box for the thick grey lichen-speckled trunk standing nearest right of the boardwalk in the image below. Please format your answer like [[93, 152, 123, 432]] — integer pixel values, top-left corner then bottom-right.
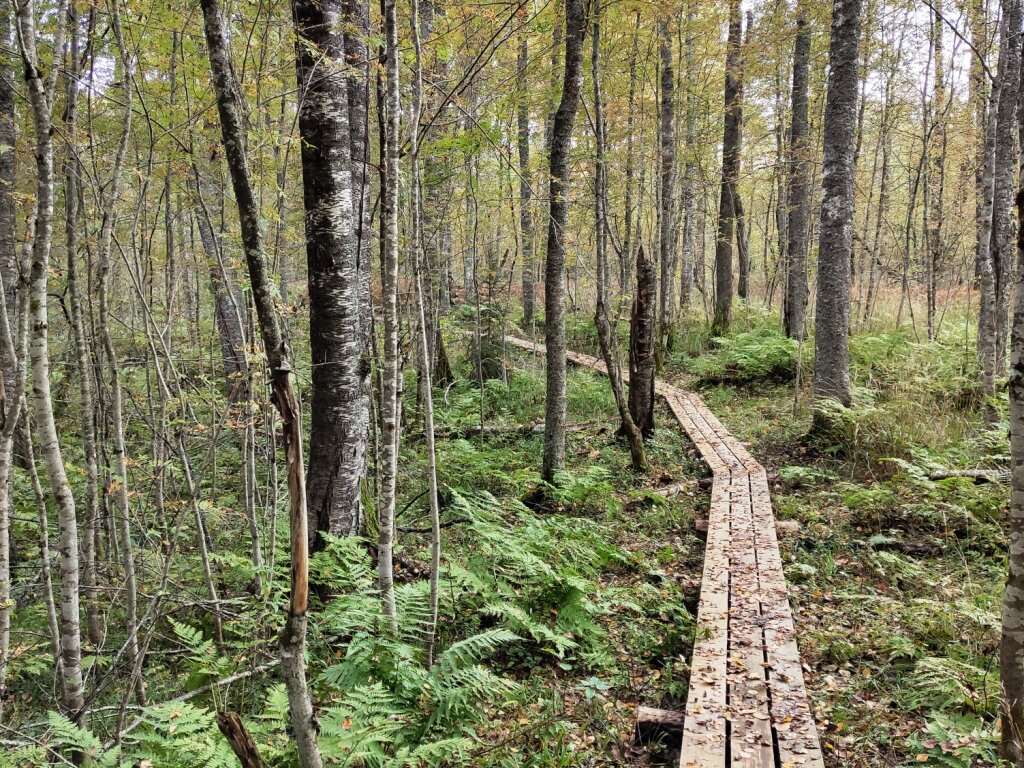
[[814, 0, 862, 413]]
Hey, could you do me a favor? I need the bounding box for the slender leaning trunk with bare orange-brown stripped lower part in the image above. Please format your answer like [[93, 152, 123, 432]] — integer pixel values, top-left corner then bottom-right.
[[202, 0, 324, 768]]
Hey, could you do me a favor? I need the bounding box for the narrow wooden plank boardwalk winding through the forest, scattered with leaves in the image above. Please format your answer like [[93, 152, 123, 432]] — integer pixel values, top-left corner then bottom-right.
[[506, 337, 824, 768]]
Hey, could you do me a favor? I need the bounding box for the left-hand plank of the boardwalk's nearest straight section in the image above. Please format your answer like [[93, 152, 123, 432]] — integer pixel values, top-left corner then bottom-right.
[[679, 474, 729, 768]]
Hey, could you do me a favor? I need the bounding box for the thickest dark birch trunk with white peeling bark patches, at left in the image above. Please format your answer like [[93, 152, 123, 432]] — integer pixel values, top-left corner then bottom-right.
[[292, 0, 370, 548]]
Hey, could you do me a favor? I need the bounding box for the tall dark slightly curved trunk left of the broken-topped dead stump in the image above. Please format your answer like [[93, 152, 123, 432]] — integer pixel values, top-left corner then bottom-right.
[[542, 0, 586, 482]]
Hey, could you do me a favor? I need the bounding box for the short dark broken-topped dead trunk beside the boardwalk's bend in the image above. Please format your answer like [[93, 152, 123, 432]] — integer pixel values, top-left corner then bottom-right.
[[630, 246, 657, 437]]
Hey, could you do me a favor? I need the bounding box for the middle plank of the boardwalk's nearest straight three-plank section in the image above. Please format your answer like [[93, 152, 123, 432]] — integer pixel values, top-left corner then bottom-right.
[[728, 473, 775, 768]]
